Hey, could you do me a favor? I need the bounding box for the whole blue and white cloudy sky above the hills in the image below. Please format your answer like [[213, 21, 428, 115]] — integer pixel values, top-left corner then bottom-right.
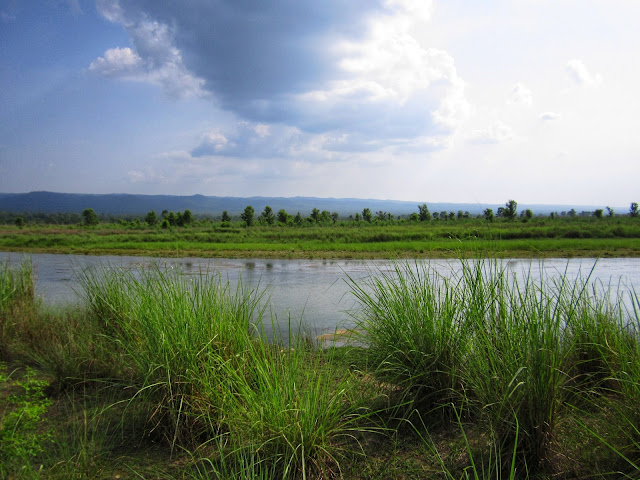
[[0, 0, 640, 208]]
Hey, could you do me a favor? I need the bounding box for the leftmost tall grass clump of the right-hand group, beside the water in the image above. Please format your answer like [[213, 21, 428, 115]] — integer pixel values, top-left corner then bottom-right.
[[349, 263, 469, 411]]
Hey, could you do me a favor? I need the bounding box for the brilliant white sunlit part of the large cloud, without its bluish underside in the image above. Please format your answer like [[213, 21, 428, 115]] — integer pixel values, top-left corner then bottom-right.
[[318, 0, 469, 128]]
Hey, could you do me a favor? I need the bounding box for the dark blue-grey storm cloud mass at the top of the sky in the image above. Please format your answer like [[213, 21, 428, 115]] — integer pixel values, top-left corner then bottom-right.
[[107, 0, 381, 121]]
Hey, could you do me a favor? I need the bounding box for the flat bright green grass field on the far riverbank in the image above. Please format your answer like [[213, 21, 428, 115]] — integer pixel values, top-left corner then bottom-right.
[[0, 217, 640, 258]]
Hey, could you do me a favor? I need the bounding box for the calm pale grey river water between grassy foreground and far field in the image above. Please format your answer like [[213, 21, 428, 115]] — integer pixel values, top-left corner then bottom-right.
[[0, 252, 640, 334]]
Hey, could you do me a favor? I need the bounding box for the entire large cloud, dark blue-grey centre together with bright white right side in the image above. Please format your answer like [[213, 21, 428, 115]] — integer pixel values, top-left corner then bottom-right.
[[90, 0, 470, 155]]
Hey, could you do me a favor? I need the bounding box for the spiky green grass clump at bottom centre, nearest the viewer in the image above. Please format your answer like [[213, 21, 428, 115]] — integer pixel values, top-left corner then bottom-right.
[[209, 338, 369, 478]]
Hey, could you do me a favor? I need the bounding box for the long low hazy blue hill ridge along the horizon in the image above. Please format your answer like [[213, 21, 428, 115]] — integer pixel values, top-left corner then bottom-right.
[[0, 192, 612, 216]]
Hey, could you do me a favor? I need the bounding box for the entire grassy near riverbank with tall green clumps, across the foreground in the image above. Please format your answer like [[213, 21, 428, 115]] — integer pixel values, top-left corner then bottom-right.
[[0, 259, 640, 479]]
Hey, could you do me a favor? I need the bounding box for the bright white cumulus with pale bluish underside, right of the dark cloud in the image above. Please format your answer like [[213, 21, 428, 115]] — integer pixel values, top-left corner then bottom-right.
[[298, 0, 469, 133]]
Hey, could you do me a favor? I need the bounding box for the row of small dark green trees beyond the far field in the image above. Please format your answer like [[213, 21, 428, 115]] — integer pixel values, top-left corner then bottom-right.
[[0, 200, 640, 229]]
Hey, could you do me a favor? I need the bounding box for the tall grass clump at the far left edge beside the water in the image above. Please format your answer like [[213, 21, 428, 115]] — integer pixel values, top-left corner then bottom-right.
[[0, 260, 35, 360]]
